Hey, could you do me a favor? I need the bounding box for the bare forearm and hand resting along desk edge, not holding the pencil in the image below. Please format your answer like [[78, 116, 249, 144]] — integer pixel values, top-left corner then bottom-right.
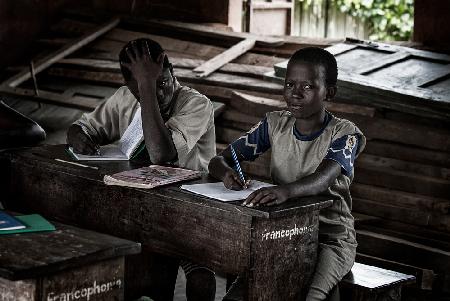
[[243, 160, 341, 207]]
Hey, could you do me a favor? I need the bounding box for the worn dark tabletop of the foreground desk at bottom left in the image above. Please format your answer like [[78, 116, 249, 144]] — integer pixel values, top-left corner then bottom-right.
[[0, 222, 141, 280]]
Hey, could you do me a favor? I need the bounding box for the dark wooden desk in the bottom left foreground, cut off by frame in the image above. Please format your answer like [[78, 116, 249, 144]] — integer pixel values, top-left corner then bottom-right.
[[0, 218, 141, 301]]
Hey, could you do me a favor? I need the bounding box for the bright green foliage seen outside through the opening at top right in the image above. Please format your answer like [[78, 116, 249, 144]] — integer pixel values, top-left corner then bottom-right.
[[299, 0, 414, 41]]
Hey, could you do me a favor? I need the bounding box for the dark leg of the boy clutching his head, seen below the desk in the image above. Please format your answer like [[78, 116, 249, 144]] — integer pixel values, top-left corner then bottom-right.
[[180, 260, 216, 301]]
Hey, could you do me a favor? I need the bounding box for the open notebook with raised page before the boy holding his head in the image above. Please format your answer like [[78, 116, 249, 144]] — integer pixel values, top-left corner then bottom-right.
[[68, 108, 145, 161]]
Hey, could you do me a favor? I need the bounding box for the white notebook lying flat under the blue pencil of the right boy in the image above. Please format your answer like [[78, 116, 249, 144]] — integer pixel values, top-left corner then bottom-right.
[[181, 180, 273, 202]]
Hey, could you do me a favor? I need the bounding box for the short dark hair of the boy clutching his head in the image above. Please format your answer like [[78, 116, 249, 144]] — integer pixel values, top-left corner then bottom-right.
[[119, 38, 173, 81]]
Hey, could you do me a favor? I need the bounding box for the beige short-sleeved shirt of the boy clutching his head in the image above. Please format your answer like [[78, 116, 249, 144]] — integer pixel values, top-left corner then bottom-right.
[[74, 81, 216, 171]]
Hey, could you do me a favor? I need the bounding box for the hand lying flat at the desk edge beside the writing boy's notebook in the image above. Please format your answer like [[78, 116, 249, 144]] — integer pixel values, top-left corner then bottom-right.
[[242, 186, 289, 207]]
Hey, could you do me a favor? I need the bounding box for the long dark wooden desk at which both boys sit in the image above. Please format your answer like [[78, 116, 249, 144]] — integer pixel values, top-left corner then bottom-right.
[[1, 146, 332, 300]]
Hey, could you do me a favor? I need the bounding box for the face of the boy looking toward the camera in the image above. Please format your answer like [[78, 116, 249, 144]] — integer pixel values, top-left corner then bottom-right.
[[283, 62, 328, 119]]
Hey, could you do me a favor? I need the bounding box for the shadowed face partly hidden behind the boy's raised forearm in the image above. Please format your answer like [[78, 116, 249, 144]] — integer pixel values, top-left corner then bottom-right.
[[126, 68, 175, 112]]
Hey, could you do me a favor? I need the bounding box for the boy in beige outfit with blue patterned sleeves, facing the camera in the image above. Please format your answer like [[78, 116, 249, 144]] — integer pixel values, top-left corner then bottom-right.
[[209, 47, 365, 301]]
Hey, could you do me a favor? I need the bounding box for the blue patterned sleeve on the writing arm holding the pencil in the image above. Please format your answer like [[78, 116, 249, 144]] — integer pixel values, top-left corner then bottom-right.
[[232, 117, 270, 161]]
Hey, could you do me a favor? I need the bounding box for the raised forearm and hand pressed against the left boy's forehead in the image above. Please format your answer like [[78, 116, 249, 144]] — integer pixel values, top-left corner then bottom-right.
[[127, 45, 177, 164]]
